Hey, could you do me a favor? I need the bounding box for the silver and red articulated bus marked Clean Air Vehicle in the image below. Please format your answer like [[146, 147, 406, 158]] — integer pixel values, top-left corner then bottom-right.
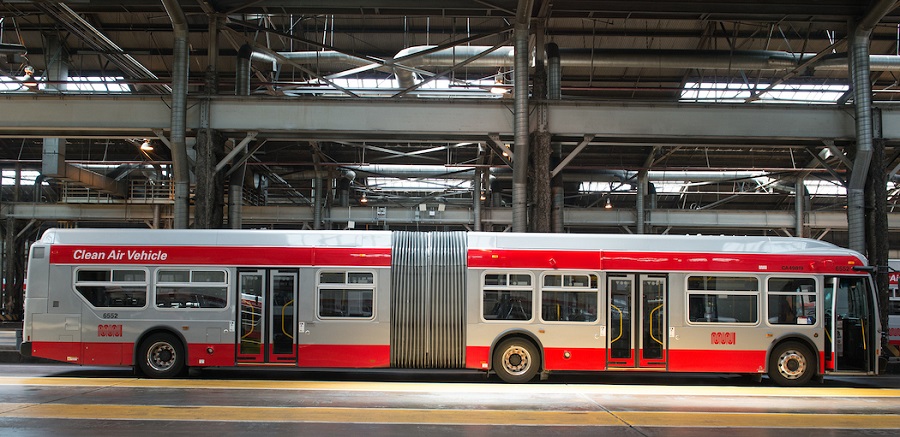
[[21, 229, 882, 386]]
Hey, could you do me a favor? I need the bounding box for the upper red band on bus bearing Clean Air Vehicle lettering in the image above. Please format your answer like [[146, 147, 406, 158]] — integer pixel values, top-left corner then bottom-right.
[[50, 245, 391, 266]]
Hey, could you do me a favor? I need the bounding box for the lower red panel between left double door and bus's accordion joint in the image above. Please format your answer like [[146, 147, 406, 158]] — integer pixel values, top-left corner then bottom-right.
[[297, 344, 391, 369]]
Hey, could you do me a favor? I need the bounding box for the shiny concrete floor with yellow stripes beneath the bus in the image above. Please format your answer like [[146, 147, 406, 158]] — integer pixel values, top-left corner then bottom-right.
[[0, 364, 900, 437]]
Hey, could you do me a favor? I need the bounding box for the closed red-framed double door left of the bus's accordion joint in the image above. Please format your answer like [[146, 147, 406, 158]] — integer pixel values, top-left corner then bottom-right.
[[237, 269, 298, 364]]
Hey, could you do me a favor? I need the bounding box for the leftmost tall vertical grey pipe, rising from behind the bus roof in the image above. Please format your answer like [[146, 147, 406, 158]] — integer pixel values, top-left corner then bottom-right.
[[162, 0, 191, 229]]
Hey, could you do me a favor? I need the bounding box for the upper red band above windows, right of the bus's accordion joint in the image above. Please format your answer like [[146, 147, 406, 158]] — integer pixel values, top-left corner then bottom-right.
[[468, 249, 862, 274]]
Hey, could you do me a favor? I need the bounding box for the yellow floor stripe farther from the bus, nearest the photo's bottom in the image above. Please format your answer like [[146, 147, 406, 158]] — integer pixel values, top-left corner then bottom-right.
[[0, 403, 900, 429]]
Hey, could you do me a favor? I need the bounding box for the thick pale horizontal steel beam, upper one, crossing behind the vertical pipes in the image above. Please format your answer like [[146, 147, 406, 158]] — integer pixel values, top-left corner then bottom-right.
[[0, 94, 900, 143]]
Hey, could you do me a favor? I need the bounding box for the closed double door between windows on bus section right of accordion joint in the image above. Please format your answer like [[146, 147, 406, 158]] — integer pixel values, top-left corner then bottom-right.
[[606, 274, 668, 369]]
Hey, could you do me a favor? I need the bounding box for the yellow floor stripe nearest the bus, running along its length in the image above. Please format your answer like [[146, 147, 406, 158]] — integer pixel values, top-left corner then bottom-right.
[[0, 376, 900, 398]]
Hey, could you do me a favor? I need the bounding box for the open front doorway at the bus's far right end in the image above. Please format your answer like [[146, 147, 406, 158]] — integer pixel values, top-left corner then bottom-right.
[[824, 276, 880, 374]]
